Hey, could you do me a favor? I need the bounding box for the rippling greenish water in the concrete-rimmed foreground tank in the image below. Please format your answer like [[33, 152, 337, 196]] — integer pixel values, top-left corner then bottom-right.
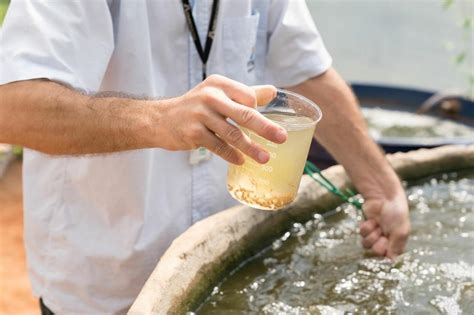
[[197, 171, 474, 315]]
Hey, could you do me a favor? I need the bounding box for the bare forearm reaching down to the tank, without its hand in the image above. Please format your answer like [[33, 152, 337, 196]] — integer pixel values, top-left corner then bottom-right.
[[289, 69, 401, 198]]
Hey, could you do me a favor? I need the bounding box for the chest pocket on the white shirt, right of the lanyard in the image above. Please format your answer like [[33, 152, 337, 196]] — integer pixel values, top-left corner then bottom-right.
[[223, 12, 260, 85]]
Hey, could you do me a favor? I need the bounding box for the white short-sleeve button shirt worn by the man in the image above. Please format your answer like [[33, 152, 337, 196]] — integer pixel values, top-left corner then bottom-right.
[[0, 0, 331, 314]]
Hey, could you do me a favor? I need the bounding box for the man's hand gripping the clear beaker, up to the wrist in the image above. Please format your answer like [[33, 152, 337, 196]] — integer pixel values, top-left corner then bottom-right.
[[156, 75, 287, 164]]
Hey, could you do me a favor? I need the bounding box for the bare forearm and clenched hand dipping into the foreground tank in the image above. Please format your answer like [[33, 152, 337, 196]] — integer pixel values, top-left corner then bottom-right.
[[289, 68, 410, 259]]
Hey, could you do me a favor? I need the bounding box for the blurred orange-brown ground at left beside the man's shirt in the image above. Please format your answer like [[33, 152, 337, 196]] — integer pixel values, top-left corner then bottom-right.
[[0, 161, 39, 315]]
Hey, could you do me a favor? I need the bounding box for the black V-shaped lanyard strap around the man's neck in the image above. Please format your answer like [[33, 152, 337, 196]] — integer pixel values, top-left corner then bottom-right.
[[181, 0, 219, 80]]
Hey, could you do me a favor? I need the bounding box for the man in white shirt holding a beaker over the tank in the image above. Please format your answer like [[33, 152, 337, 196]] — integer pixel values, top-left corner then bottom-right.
[[0, 0, 409, 314]]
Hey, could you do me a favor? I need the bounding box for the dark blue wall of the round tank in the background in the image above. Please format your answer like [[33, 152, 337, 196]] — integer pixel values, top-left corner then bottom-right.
[[308, 84, 474, 168]]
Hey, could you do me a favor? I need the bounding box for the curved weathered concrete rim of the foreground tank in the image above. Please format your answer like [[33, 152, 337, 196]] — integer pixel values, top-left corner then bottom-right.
[[129, 145, 474, 314]]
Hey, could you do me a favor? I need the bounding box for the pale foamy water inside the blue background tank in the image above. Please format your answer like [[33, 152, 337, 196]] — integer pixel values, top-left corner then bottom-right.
[[362, 108, 474, 140]]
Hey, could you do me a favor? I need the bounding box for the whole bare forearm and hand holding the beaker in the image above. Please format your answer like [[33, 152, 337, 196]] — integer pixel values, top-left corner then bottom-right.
[[0, 75, 287, 159]]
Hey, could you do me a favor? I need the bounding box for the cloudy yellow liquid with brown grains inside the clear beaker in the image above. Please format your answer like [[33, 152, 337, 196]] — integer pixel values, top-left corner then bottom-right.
[[227, 113, 316, 210]]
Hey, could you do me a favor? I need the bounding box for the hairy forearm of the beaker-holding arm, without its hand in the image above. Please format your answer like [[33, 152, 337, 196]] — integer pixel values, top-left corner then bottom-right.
[[0, 80, 156, 155]]
